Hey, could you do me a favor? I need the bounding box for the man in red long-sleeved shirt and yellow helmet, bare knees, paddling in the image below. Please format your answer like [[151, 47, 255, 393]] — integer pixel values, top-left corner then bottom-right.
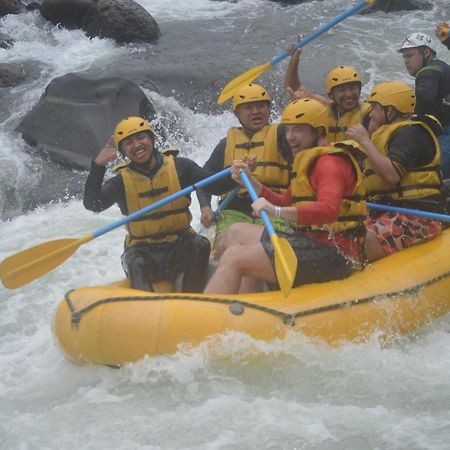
[[205, 99, 367, 294]]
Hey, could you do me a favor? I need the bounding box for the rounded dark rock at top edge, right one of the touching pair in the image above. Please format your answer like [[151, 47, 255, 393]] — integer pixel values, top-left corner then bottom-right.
[[83, 0, 160, 43]]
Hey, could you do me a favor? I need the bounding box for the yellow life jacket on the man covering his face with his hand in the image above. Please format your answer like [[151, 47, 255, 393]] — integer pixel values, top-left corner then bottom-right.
[[364, 119, 441, 201]]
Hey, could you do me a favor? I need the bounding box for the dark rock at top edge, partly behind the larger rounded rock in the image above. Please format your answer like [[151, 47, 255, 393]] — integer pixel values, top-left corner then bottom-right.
[[39, 0, 97, 29]]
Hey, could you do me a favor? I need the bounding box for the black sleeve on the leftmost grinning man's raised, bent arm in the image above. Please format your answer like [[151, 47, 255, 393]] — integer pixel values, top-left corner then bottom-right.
[[83, 161, 128, 215]]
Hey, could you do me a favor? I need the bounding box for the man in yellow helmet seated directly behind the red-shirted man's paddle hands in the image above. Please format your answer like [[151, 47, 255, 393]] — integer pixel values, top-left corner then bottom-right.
[[198, 83, 291, 253]]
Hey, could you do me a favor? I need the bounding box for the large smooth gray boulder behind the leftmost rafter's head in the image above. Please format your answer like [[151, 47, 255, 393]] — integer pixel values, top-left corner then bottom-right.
[[17, 73, 155, 169]]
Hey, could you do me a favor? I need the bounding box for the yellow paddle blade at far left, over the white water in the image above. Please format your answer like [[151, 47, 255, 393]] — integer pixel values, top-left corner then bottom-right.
[[0, 235, 93, 289]]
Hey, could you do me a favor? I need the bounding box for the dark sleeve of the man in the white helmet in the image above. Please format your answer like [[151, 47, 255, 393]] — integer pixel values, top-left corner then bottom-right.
[[415, 64, 443, 115]]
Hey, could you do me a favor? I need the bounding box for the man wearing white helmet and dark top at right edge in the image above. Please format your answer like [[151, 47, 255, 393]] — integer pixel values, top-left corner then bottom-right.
[[398, 33, 450, 178]]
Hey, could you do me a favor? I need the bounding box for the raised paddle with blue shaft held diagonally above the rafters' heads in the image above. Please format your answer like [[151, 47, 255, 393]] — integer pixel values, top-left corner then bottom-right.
[[217, 0, 376, 105]]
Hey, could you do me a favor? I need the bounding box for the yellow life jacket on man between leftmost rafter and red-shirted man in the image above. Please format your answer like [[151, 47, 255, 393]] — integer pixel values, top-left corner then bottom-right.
[[224, 124, 289, 195]]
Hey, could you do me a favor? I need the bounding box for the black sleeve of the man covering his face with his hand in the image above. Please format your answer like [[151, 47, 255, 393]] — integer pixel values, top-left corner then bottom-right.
[[388, 125, 436, 176]]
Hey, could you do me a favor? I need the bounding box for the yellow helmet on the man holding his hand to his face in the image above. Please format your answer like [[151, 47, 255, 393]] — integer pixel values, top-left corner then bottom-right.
[[367, 81, 416, 114]]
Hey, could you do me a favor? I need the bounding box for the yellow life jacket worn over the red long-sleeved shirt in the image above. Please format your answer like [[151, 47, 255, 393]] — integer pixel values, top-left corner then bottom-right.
[[291, 141, 367, 234]]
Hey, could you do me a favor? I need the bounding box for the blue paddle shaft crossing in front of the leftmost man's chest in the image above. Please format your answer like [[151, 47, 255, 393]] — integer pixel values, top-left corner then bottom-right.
[[92, 167, 231, 238]]
